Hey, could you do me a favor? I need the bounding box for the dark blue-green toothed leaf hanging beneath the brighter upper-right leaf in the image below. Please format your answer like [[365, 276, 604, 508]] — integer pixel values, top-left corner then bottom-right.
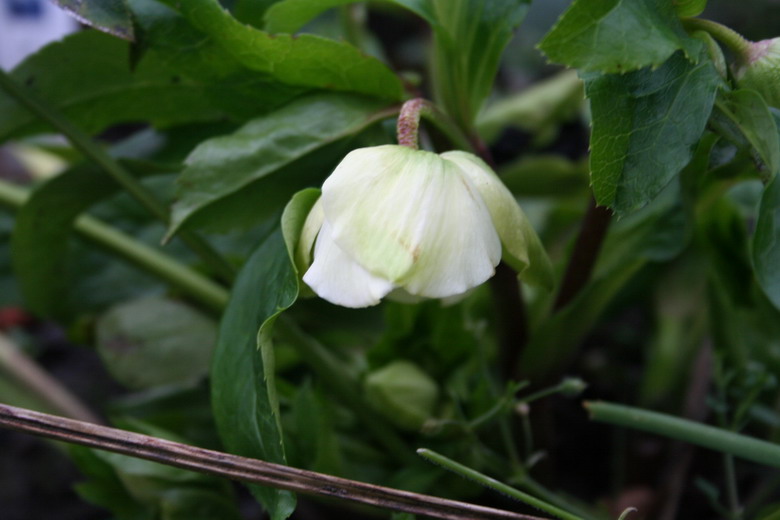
[[585, 53, 720, 214]]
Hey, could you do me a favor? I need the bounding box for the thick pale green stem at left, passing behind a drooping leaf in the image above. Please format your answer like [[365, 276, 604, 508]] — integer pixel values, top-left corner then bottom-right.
[[0, 181, 228, 312]]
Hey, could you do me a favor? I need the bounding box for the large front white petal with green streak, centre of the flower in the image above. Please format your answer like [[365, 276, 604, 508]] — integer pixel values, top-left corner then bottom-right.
[[322, 145, 501, 298]]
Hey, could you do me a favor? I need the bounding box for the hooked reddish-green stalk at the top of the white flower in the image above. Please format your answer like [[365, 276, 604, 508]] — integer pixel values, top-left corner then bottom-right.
[[396, 98, 474, 152]]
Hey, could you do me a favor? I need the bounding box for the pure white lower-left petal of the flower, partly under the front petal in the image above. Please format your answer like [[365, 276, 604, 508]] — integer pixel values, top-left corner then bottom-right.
[[303, 222, 393, 308]]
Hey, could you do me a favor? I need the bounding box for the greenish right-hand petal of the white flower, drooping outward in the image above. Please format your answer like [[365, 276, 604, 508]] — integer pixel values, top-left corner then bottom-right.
[[441, 151, 555, 290]]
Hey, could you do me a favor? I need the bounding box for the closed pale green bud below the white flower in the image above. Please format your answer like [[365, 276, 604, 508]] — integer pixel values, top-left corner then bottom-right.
[[366, 361, 439, 431]]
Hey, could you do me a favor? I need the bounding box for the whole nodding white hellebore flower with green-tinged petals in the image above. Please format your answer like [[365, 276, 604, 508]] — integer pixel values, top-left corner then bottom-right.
[[296, 145, 552, 307]]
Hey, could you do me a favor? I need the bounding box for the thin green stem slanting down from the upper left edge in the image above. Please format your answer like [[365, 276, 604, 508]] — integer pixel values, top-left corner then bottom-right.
[[0, 69, 235, 282]]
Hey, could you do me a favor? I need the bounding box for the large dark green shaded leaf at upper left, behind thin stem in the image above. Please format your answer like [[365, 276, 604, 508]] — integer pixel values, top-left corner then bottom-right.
[[0, 27, 301, 141]]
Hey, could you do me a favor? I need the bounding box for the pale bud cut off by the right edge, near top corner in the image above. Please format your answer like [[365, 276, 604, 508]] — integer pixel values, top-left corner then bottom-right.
[[734, 38, 780, 107]]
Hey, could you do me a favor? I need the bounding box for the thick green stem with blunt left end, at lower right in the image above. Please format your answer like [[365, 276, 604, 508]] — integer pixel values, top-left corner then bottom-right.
[[585, 402, 780, 468]]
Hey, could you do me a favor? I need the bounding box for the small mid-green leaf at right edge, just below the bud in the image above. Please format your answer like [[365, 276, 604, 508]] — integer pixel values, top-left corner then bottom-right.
[[711, 90, 780, 179]]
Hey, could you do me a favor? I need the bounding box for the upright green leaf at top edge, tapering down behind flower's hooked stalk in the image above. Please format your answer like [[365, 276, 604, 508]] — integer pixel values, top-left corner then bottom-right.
[[430, 0, 530, 130]]
